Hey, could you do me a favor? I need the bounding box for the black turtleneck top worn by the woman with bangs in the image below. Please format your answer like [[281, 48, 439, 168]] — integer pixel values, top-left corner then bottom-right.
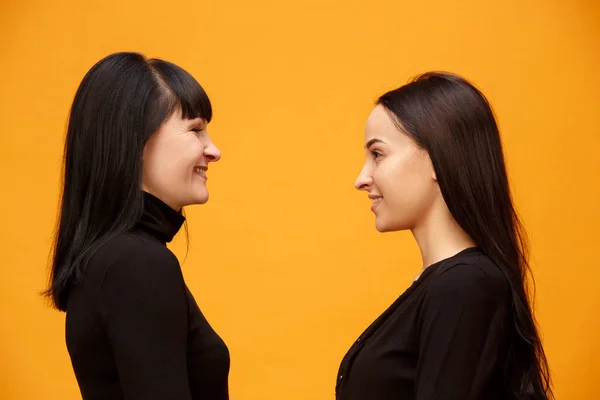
[[66, 193, 229, 400]]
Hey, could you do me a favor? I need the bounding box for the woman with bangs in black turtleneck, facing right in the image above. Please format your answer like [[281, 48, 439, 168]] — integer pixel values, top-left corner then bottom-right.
[[46, 53, 229, 400]]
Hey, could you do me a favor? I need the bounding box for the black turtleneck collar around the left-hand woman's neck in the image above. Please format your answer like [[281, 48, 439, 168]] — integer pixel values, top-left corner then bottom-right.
[[137, 191, 185, 244]]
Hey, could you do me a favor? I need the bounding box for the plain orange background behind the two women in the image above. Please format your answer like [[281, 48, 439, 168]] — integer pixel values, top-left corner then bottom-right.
[[0, 0, 600, 400]]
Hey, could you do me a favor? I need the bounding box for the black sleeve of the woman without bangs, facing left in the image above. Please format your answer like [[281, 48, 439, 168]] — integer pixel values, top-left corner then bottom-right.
[[415, 265, 510, 400]]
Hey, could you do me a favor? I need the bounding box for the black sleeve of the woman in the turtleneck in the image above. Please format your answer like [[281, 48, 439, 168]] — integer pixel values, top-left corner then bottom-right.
[[102, 247, 192, 400]]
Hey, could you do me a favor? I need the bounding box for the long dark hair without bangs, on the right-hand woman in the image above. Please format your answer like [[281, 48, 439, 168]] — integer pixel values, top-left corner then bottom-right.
[[377, 72, 553, 400]]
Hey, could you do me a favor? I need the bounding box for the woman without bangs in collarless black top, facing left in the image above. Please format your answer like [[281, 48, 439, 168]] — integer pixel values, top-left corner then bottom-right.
[[336, 72, 552, 400]]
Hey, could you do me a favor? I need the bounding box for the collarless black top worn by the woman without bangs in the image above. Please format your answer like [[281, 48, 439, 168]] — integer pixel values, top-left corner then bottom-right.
[[336, 248, 514, 400]]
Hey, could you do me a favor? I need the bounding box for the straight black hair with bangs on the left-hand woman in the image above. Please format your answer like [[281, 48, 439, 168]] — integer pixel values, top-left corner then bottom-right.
[[44, 52, 212, 311]]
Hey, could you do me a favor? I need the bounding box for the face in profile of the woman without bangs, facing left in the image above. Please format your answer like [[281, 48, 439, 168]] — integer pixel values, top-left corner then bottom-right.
[[355, 105, 441, 232]]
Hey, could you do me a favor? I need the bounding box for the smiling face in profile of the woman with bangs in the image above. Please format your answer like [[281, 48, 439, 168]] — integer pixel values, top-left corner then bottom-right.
[[142, 110, 221, 210]]
